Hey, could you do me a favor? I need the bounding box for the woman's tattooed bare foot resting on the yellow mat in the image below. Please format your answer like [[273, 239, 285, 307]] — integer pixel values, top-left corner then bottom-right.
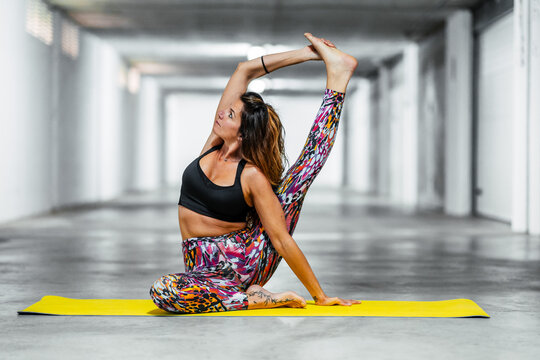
[[246, 285, 306, 309]]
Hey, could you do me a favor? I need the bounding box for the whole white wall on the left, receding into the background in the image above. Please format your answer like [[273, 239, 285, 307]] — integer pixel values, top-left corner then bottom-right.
[[0, 1, 139, 222]]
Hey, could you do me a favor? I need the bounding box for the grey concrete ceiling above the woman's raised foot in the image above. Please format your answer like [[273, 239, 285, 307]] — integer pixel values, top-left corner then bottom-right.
[[41, 0, 481, 86]]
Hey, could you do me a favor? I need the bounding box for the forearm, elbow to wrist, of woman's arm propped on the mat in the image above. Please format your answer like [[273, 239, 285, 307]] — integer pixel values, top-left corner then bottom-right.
[[278, 237, 326, 301]]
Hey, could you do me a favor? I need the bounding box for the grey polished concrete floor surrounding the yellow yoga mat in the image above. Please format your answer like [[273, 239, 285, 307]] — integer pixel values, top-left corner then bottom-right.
[[0, 188, 540, 360]]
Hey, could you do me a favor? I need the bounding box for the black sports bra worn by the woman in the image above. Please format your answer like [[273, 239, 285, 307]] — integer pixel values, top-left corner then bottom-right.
[[178, 145, 252, 222]]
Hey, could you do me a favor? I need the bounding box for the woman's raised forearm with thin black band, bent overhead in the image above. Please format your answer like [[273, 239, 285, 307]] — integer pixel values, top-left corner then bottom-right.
[[242, 47, 311, 80]]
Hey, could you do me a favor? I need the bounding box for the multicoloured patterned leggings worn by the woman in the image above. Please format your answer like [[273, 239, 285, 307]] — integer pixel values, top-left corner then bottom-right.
[[150, 88, 345, 313]]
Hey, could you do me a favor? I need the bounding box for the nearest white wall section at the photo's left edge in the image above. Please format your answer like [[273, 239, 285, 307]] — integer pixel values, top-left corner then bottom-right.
[[0, 1, 53, 221]]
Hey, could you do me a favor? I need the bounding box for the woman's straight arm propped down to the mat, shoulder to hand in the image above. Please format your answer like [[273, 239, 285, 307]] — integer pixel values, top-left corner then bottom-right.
[[244, 167, 360, 305]]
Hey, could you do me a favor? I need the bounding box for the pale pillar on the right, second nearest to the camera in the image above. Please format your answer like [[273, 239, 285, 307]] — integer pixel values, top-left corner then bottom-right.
[[444, 10, 473, 216]]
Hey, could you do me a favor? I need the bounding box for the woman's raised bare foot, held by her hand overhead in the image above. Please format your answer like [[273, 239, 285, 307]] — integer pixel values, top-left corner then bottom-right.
[[304, 33, 358, 75]]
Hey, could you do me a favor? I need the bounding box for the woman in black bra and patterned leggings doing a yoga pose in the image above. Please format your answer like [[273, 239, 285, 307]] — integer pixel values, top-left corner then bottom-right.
[[150, 33, 360, 313]]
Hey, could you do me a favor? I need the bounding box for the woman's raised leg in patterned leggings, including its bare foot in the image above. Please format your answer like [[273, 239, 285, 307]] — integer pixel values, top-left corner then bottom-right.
[[244, 34, 358, 288]]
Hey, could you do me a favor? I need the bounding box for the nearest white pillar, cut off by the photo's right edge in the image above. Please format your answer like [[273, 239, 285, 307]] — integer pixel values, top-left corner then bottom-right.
[[512, 0, 540, 235]]
